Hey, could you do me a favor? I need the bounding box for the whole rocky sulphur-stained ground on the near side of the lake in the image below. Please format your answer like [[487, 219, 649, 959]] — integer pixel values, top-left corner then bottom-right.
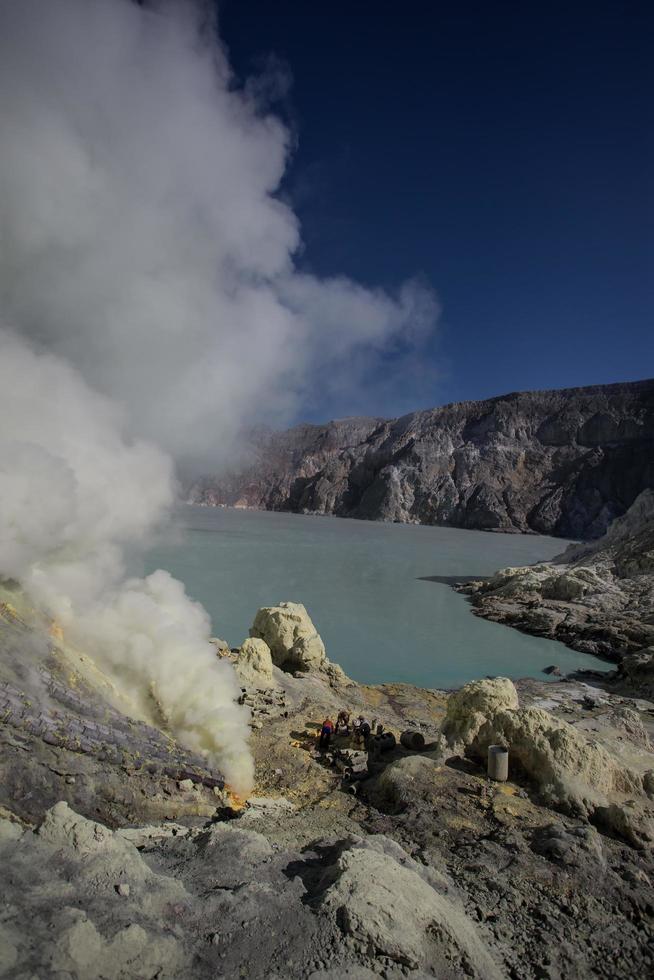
[[0, 596, 654, 980]]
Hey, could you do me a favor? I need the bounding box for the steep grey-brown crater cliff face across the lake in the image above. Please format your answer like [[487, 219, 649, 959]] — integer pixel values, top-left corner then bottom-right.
[[189, 381, 654, 538]]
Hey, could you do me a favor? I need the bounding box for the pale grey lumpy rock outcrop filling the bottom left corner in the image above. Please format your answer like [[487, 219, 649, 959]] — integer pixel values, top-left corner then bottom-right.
[[0, 802, 187, 980]]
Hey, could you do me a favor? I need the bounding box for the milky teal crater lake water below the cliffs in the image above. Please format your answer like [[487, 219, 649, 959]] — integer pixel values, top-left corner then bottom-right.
[[143, 506, 608, 688]]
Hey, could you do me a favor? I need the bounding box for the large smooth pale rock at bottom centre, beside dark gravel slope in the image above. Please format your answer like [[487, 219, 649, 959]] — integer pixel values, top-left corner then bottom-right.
[[323, 838, 501, 980]]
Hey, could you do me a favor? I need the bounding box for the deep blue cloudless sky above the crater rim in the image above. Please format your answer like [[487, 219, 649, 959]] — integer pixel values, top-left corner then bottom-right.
[[220, 0, 654, 415]]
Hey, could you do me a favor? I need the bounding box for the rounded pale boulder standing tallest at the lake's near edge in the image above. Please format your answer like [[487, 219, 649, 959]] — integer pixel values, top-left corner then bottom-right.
[[250, 602, 326, 671]]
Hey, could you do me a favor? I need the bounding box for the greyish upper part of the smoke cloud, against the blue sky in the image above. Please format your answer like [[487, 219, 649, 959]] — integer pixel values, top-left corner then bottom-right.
[[0, 0, 437, 463]]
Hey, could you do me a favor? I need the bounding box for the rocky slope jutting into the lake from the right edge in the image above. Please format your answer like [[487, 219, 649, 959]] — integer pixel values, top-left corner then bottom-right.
[[459, 490, 654, 668]]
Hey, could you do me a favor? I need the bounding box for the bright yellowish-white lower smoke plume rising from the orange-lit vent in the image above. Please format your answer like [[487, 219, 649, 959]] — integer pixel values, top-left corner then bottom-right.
[[0, 330, 253, 792]]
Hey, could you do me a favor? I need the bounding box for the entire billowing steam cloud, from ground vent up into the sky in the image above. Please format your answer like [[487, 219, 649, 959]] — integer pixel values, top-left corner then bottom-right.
[[0, 0, 444, 787]]
